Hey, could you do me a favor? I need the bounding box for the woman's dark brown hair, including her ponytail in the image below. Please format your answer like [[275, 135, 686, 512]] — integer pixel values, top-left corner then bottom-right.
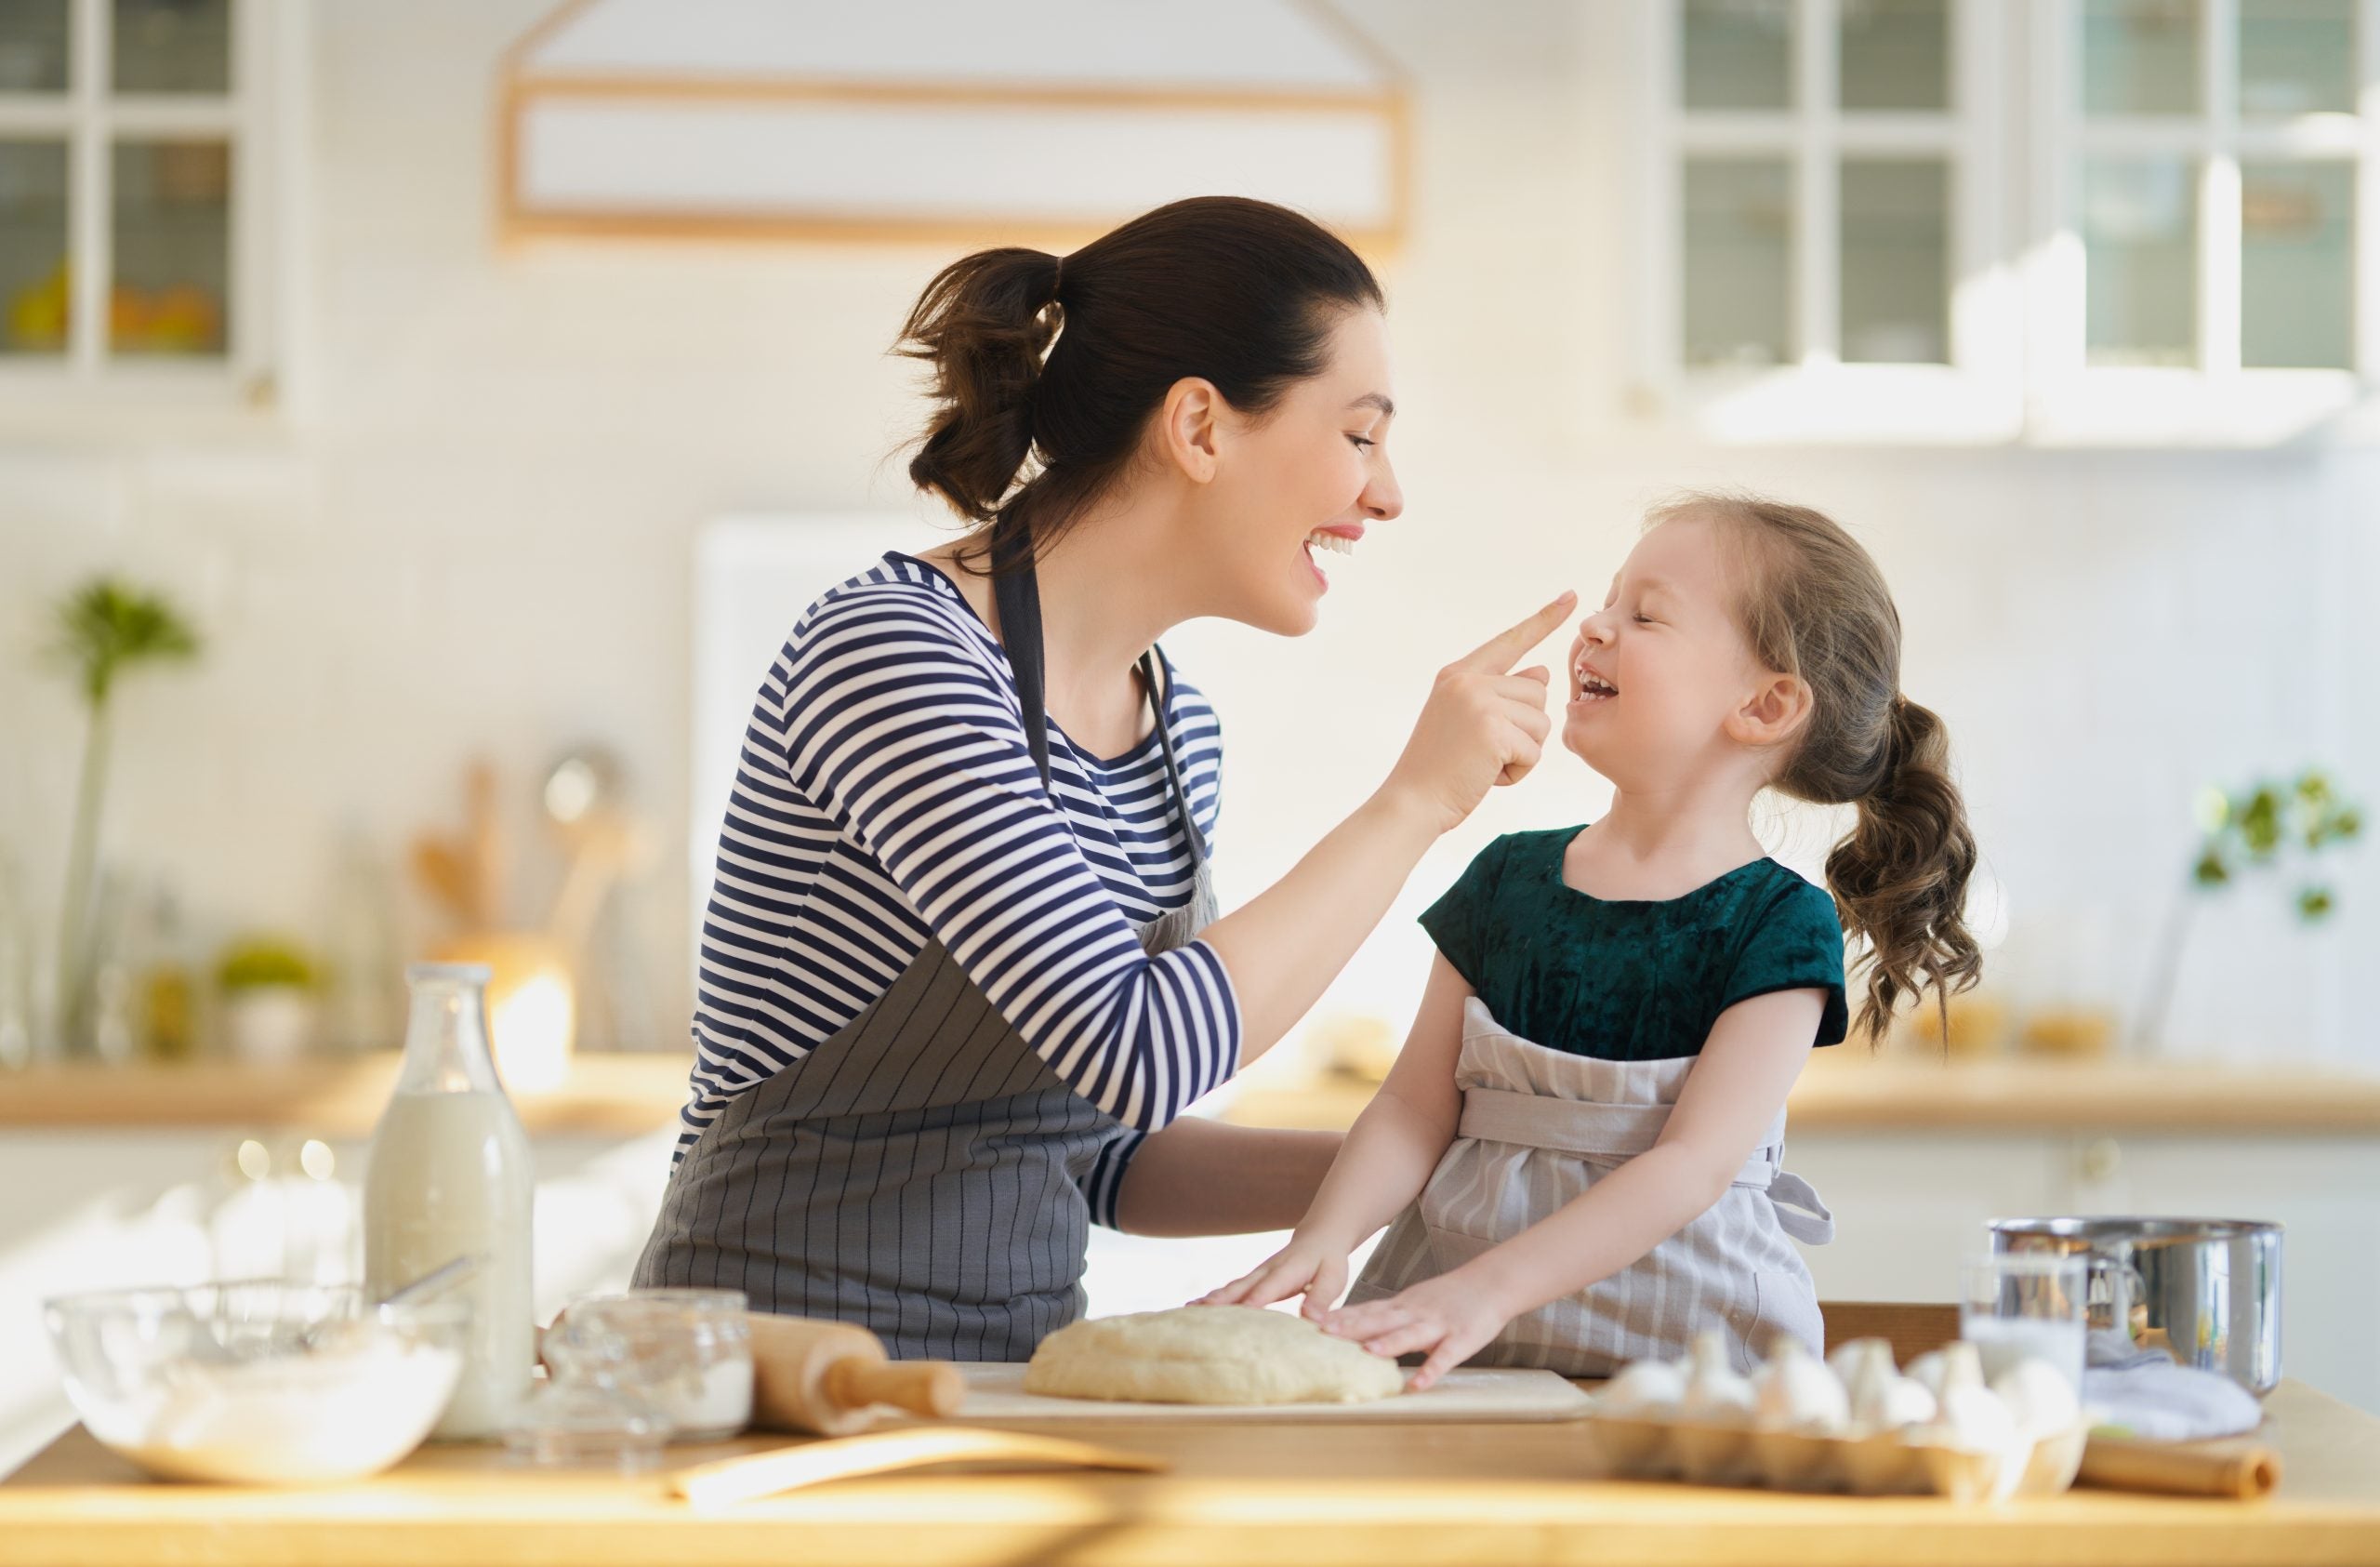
[[900, 195, 1381, 569]]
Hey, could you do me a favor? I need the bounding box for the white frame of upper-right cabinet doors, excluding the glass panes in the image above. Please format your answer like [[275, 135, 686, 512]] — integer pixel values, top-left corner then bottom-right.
[[1625, 0, 2380, 447]]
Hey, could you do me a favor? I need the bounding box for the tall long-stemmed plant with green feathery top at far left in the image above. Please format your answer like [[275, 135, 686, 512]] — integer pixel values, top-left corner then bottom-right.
[[50, 577, 197, 1048]]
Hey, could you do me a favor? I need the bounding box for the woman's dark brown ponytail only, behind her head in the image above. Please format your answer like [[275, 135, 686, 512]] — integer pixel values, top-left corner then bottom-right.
[[900, 246, 1059, 522]]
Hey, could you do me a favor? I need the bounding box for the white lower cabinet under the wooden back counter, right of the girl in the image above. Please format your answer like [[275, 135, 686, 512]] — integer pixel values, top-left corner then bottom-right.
[[1785, 1131, 2380, 1410]]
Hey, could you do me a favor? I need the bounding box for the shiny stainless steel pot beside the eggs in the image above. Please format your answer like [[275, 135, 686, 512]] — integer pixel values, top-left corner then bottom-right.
[[1990, 1217, 2280, 1398]]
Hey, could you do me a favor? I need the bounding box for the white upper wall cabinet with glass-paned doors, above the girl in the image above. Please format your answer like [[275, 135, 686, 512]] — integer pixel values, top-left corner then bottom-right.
[[1631, 0, 2380, 445]]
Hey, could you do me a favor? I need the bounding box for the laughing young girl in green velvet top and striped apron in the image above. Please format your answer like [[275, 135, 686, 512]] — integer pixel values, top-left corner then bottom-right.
[[1207, 496, 1980, 1388]]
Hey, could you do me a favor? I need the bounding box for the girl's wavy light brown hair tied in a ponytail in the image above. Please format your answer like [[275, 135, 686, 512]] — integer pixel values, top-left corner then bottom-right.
[[1652, 496, 1982, 1041]]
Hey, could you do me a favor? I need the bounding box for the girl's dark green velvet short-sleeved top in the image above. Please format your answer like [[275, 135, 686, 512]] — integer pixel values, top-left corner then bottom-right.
[[1421, 827, 1847, 1062]]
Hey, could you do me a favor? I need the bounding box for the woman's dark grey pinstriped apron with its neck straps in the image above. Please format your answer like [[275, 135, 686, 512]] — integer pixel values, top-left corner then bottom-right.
[[636, 550, 1214, 1360]]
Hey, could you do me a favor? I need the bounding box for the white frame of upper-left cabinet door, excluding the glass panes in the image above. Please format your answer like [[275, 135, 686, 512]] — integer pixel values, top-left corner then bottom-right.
[[0, 0, 290, 424]]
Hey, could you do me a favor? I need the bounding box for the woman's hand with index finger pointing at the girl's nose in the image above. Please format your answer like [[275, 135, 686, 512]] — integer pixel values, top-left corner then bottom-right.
[[1381, 593, 1578, 833]]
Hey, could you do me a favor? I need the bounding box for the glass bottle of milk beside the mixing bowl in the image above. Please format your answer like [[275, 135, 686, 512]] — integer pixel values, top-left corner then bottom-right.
[[364, 963, 538, 1441]]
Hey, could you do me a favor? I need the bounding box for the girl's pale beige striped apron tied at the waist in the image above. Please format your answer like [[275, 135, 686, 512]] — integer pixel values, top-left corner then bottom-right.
[[1347, 995, 1835, 1376]]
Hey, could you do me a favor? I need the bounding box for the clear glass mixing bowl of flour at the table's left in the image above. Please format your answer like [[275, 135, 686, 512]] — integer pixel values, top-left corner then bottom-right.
[[43, 1279, 471, 1486]]
